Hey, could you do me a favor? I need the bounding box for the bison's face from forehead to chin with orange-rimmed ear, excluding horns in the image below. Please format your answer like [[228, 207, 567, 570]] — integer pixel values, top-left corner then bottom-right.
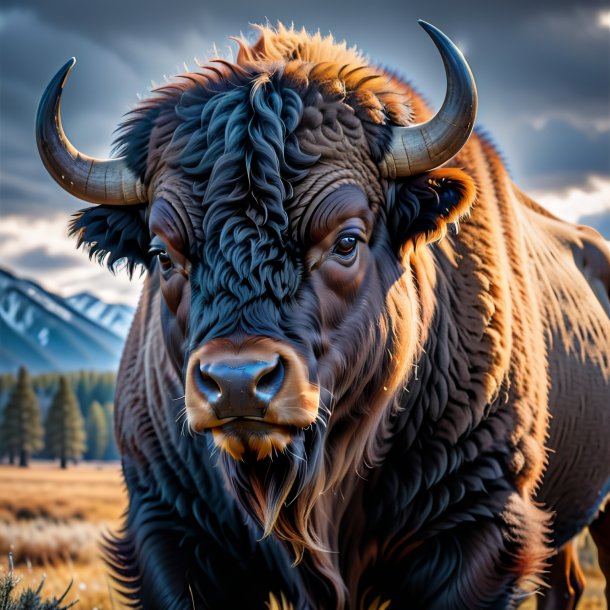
[[148, 101, 476, 462]]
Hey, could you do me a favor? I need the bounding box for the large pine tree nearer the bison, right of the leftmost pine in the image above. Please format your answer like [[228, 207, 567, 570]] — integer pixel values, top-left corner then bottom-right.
[[47, 375, 86, 468]]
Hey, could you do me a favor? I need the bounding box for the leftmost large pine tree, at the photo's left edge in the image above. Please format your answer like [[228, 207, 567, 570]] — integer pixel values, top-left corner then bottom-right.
[[1, 367, 44, 467]]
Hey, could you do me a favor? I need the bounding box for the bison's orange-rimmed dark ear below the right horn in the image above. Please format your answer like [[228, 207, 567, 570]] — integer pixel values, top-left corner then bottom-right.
[[389, 168, 476, 249]]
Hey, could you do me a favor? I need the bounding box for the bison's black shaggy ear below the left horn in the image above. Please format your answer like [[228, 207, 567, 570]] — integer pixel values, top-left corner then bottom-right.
[[70, 205, 150, 277]]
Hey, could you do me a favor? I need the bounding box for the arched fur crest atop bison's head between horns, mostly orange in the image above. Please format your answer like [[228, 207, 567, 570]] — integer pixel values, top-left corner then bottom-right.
[[117, 24, 426, 180]]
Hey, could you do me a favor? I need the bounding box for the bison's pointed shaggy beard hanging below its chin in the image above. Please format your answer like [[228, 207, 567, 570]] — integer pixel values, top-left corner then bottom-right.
[[216, 425, 326, 565]]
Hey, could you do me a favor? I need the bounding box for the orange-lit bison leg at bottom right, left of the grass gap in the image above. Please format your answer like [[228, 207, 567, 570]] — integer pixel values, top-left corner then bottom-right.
[[538, 541, 585, 610]]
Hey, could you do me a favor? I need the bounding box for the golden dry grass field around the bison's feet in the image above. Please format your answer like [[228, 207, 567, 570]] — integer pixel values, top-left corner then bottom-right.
[[0, 463, 606, 610]]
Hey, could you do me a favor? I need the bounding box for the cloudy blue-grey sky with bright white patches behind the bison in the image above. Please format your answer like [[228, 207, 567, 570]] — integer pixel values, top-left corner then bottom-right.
[[0, 0, 610, 302]]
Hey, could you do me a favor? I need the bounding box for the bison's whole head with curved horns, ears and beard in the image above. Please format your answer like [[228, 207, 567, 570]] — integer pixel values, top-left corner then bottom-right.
[[37, 24, 476, 555]]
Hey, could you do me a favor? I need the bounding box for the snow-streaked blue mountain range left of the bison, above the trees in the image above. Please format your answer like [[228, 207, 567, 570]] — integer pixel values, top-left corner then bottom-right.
[[0, 268, 133, 373]]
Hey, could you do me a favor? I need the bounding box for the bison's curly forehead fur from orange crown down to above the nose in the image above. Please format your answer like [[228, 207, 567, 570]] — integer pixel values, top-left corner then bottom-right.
[[108, 25, 428, 342]]
